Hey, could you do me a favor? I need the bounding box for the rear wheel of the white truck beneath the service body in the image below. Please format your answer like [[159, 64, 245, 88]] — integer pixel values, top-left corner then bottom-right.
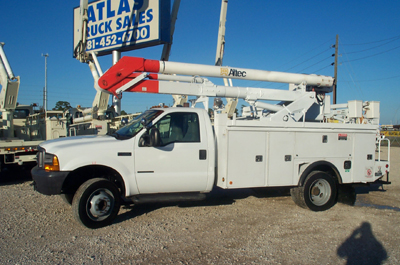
[[290, 171, 337, 212]]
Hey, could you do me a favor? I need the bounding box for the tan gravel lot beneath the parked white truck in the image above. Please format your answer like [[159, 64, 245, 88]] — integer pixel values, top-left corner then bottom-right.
[[0, 147, 400, 264]]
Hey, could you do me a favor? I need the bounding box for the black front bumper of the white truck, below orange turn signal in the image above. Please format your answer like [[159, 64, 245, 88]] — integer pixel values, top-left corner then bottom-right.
[[31, 166, 70, 195]]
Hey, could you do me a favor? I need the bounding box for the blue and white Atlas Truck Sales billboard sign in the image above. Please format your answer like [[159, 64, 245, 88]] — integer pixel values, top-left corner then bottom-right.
[[74, 0, 171, 55]]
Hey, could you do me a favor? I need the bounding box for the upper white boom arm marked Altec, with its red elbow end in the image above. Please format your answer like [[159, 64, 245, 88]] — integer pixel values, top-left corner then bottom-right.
[[99, 57, 333, 96]]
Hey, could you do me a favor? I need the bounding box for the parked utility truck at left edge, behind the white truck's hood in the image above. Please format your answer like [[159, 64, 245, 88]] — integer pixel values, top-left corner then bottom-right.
[[0, 43, 67, 171]]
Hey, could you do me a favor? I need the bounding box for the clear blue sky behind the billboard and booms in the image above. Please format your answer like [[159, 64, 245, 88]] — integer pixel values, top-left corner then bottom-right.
[[0, 0, 400, 124]]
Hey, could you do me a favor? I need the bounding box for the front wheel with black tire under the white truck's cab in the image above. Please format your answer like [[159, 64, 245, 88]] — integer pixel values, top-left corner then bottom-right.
[[72, 178, 121, 229]]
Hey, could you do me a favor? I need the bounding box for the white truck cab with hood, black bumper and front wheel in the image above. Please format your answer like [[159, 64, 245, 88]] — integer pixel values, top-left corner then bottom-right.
[[32, 108, 215, 227]]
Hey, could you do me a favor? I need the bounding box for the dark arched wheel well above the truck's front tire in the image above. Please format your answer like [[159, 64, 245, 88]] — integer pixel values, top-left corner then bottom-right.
[[62, 165, 125, 196]]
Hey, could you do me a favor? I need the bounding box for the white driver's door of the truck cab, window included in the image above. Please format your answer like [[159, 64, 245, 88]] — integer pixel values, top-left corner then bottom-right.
[[135, 112, 208, 194]]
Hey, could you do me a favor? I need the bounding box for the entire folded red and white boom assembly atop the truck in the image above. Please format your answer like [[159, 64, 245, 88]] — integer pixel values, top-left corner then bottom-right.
[[98, 57, 333, 121]]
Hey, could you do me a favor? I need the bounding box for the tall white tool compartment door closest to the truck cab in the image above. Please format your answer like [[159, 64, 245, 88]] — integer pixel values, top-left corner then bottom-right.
[[227, 131, 267, 188]]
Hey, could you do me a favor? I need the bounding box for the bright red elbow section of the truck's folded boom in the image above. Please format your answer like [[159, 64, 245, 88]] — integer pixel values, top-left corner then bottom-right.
[[98, 56, 160, 95]]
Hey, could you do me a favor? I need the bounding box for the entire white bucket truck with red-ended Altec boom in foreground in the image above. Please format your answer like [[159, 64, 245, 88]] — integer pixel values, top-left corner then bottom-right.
[[32, 57, 389, 228]]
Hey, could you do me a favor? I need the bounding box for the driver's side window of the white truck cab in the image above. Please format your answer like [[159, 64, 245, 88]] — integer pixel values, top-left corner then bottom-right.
[[154, 112, 200, 146]]
